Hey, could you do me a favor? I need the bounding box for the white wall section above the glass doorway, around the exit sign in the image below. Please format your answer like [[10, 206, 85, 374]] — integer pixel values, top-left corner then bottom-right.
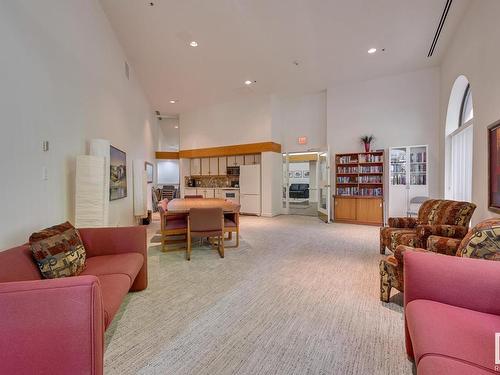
[[272, 91, 327, 152]]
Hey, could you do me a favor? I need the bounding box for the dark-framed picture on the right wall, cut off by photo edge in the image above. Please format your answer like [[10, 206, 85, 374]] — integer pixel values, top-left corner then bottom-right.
[[488, 121, 500, 213]]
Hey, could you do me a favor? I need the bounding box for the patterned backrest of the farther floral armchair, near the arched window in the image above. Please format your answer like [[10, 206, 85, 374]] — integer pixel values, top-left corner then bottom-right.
[[418, 199, 476, 227]]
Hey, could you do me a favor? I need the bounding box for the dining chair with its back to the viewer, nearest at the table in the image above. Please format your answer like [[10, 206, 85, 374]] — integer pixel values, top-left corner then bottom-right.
[[186, 207, 224, 260]]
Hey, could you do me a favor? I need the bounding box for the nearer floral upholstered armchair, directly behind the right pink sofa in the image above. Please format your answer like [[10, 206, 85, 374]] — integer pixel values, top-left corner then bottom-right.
[[380, 218, 500, 302]]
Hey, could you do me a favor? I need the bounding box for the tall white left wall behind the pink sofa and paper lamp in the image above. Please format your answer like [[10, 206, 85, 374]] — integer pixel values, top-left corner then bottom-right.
[[0, 0, 158, 249]]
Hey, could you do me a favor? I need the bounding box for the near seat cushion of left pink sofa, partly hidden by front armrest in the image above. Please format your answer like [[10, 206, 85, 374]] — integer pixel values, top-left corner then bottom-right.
[[97, 274, 130, 329]]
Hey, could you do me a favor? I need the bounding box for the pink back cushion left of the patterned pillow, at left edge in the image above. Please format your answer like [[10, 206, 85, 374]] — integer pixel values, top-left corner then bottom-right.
[[0, 244, 42, 283]]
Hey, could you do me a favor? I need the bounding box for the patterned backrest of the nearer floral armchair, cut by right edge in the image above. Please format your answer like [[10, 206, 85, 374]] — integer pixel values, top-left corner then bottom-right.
[[456, 218, 500, 260]]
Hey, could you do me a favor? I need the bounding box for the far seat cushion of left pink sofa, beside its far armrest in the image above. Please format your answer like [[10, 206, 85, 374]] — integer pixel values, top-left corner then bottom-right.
[[81, 253, 144, 288]]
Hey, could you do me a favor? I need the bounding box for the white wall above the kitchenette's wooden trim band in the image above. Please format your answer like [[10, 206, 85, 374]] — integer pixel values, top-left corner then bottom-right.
[[179, 96, 271, 150]]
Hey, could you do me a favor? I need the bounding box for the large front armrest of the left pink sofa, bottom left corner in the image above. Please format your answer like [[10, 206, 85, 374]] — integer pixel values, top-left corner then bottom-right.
[[0, 276, 104, 375]]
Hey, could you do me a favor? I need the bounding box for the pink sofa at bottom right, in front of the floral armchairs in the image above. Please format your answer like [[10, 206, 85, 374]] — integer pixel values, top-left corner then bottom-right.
[[404, 251, 500, 375]]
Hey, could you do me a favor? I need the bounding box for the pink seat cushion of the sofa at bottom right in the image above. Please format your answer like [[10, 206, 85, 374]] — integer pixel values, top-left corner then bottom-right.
[[405, 300, 500, 371]]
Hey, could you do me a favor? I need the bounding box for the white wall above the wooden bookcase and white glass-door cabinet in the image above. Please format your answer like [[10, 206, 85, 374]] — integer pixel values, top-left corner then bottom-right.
[[327, 68, 441, 201]]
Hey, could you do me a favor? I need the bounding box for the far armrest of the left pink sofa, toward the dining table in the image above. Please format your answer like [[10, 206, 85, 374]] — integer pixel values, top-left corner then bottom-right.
[[78, 226, 148, 291]]
